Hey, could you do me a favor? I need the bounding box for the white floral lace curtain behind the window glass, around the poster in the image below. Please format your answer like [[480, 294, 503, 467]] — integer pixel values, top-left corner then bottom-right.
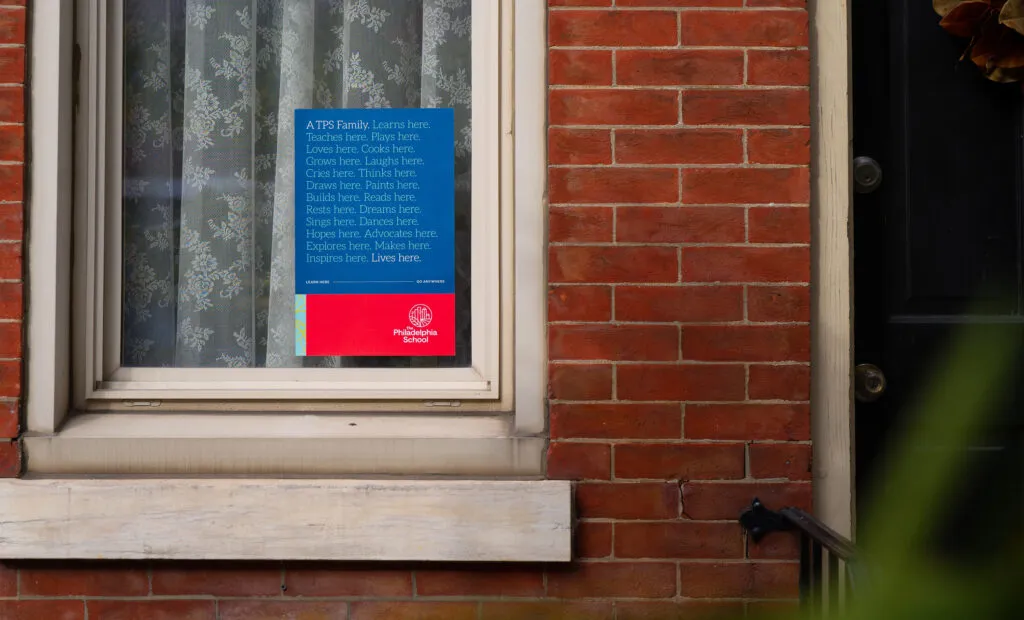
[[122, 0, 471, 367]]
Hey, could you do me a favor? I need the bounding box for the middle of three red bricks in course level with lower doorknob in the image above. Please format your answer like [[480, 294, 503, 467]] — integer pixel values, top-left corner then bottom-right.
[[615, 362, 745, 401]]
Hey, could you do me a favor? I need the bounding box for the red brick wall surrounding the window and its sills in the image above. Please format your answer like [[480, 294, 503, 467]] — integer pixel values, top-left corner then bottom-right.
[[0, 0, 811, 620]]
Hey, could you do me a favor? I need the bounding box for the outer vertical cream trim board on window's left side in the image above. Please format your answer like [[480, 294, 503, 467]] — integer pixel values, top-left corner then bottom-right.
[[25, 2, 74, 431]]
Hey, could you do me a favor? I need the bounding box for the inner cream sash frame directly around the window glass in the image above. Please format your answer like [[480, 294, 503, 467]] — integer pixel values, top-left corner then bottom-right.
[[72, 0, 507, 403]]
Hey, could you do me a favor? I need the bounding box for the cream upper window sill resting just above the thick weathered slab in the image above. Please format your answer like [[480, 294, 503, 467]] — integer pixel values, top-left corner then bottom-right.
[[22, 414, 547, 478]]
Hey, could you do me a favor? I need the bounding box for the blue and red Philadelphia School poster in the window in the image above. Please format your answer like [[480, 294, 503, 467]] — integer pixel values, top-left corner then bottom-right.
[[295, 109, 455, 356]]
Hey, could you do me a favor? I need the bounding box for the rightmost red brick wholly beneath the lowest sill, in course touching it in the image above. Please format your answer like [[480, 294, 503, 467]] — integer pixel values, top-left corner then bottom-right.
[[416, 566, 544, 596]]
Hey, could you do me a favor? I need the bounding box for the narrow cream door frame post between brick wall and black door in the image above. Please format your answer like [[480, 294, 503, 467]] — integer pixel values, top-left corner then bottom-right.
[[808, 0, 856, 538]]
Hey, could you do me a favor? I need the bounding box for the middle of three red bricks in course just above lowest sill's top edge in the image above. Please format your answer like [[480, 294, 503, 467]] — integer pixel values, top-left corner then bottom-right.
[[615, 444, 744, 480]]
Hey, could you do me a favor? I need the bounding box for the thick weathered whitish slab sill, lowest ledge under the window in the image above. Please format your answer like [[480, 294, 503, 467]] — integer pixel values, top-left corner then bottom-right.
[[0, 480, 571, 562]]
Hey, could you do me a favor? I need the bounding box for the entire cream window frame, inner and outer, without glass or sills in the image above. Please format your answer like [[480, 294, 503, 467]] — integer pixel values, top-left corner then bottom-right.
[[28, 0, 546, 432]]
